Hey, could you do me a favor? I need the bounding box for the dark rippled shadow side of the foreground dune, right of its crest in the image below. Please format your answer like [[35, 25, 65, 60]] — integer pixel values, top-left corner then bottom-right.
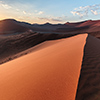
[[76, 35, 100, 100]]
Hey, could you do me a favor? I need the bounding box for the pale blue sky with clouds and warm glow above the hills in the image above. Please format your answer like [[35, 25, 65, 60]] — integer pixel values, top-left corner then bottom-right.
[[0, 0, 100, 24]]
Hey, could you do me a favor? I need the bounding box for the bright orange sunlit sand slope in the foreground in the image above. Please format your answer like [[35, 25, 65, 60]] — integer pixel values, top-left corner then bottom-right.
[[0, 34, 87, 100]]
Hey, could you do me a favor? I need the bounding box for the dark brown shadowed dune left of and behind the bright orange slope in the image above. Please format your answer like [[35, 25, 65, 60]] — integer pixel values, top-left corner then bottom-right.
[[0, 32, 75, 64]]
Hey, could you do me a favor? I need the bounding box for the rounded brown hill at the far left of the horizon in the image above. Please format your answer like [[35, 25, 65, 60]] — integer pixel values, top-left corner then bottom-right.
[[0, 19, 29, 34]]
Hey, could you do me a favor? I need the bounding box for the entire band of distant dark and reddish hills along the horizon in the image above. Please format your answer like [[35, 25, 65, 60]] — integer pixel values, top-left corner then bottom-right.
[[0, 19, 100, 37]]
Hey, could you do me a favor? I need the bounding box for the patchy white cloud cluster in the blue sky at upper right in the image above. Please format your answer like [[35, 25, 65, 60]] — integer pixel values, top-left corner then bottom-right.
[[71, 4, 100, 18]]
